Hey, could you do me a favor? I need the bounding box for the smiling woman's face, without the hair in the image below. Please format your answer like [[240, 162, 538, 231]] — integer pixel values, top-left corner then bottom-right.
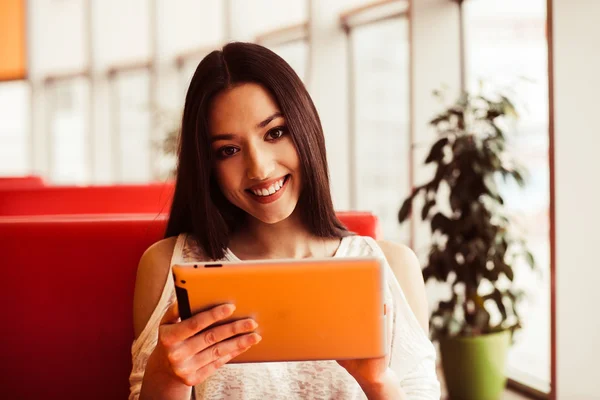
[[209, 83, 302, 224]]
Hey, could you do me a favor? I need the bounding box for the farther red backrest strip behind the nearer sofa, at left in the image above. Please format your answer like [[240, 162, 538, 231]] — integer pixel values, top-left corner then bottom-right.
[[0, 184, 174, 216]]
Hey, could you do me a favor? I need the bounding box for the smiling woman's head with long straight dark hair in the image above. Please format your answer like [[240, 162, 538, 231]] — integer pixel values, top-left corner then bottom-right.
[[166, 43, 348, 259]]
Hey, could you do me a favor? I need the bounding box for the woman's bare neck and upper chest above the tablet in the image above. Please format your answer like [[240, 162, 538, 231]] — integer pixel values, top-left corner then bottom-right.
[[229, 210, 340, 260]]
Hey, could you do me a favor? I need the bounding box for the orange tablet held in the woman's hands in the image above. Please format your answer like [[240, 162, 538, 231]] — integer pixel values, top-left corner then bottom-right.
[[173, 258, 387, 363]]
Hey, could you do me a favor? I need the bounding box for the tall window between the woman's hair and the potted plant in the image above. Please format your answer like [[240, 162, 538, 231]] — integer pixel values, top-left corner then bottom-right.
[[349, 17, 411, 243]]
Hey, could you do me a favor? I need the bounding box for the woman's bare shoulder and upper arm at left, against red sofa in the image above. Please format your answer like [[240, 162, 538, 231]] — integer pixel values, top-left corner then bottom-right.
[[133, 236, 177, 338]]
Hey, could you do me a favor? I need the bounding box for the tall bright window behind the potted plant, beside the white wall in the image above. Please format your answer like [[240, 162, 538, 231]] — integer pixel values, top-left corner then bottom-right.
[[464, 0, 550, 392]]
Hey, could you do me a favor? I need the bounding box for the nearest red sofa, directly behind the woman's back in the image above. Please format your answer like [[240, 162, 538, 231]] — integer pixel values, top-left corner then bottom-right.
[[0, 212, 379, 400]]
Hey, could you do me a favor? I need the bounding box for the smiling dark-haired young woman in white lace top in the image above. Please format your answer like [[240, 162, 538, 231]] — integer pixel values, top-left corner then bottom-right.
[[130, 43, 440, 399]]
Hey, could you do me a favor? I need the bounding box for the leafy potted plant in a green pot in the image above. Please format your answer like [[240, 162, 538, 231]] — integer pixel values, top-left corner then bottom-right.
[[398, 92, 535, 400]]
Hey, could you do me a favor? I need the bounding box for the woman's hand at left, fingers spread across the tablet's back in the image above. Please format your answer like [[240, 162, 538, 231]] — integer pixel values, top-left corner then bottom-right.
[[142, 302, 261, 388]]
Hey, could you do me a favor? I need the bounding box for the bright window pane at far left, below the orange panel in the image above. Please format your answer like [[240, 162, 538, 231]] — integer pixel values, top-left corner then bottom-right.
[[0, 81, 31, 175]]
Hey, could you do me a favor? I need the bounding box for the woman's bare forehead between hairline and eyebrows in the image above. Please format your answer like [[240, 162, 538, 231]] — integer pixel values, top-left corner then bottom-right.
[[209, 83, 280, 135]]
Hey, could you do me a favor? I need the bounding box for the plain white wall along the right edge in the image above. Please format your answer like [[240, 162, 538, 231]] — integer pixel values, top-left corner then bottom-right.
[[550, 0, 600, 400]]
